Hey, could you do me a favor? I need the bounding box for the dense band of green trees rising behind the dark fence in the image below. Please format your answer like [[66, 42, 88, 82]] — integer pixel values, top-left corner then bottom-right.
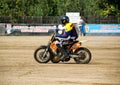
[[0, 0, 120, 18]]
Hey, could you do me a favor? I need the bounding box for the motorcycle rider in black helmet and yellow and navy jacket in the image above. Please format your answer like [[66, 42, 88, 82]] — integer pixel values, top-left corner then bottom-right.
[[56, 16, 78, 60]]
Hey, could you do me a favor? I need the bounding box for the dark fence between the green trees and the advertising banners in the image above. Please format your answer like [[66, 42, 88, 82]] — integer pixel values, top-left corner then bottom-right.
[[0, 16, 120, 24]]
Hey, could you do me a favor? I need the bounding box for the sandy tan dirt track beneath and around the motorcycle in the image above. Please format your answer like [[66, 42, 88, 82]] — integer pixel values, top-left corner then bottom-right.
[[0, 36, 120, 85]]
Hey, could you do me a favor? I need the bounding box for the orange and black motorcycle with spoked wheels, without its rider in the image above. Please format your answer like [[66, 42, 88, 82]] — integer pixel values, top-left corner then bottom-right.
[[34, 29, 92, 64]]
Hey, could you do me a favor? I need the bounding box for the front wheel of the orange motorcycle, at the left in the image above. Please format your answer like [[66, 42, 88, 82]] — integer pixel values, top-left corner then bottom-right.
[[34, 47, 50, 63]]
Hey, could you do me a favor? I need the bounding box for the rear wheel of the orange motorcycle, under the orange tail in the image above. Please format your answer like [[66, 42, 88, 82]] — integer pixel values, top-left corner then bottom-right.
[[74, 47, 92, 64]]
